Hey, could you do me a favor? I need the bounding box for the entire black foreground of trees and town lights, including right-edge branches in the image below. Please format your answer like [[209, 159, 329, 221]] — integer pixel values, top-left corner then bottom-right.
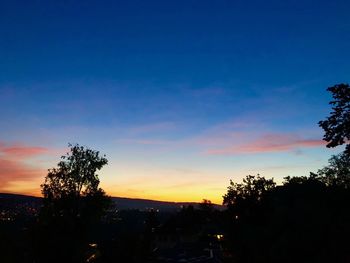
[[0, 84, 350, 263]]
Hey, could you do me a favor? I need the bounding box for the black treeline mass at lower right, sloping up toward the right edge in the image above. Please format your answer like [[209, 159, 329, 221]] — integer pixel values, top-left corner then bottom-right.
[[224, 153, 350, 263]]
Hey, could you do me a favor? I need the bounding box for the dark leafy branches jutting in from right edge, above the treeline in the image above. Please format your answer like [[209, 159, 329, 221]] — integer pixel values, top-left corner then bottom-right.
[[318, 84, 350, 153]]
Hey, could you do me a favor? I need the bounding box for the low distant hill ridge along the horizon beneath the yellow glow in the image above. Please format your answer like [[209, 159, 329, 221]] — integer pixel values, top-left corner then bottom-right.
[[0, 193, 223, 212]]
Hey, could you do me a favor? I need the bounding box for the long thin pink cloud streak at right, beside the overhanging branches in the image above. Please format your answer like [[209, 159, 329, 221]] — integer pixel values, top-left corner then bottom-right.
[[207, 134, 325, 155]]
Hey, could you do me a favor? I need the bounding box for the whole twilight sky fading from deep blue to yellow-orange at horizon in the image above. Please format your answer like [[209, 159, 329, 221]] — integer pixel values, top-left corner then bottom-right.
[[0, 0, 350, 203]]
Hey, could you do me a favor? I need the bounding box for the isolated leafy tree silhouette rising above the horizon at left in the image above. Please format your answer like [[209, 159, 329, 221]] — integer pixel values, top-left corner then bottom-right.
[[38, 144, 110, 262]]
